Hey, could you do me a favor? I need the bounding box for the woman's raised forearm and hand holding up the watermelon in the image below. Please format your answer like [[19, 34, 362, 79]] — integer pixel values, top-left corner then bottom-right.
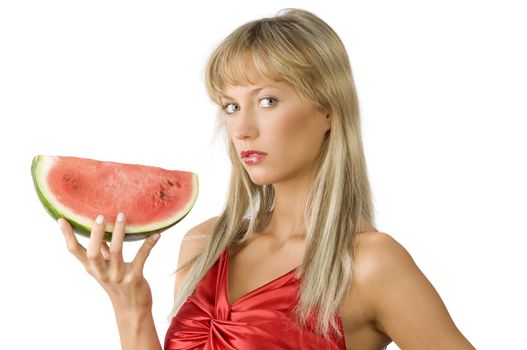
[[58, 215, 161, 350]]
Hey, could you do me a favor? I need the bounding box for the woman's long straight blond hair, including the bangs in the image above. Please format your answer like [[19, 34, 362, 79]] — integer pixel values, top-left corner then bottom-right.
[[169, 9, 374, 337]]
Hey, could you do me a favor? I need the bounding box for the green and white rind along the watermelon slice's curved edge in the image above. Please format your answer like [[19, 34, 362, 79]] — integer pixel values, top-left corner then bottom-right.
[[31, 155, 199, 242]]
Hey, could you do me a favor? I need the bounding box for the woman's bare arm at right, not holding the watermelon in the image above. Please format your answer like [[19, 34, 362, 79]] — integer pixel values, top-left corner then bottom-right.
[[356, 233, 475, 350]]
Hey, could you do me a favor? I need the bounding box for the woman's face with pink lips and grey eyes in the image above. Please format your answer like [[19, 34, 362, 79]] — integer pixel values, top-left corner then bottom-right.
[[221, 67, 330, 185]]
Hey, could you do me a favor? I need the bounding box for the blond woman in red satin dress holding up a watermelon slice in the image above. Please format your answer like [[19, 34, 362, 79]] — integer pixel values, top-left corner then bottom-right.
[[59, 6, 474, 350]]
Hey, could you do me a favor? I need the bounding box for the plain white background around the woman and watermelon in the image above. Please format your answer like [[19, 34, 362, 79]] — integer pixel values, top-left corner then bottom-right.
[[0, 0, 527, 350]]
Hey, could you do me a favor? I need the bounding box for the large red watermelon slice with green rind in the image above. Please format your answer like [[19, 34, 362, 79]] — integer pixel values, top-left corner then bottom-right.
[[31, 155, 198, 242]]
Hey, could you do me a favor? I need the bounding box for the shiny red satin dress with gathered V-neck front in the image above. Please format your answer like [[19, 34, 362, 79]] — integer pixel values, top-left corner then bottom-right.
[[164, 249, 346, 350]]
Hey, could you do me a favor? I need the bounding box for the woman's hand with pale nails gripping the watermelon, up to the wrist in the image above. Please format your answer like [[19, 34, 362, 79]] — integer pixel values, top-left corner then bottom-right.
[[57, 215, 160, 312]]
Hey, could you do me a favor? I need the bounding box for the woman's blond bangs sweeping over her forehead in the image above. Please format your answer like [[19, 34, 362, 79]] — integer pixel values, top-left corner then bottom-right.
[[205, 18, 325, 107]]
